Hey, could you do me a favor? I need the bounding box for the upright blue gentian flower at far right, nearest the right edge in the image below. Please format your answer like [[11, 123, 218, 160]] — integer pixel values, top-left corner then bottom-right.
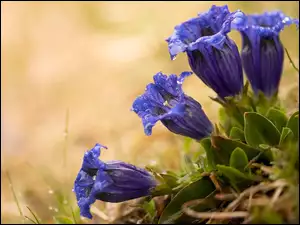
[[233, 11, 299, 97]]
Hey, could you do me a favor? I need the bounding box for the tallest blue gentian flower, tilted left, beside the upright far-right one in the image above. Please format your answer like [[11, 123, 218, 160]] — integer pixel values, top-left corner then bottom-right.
[[166, 5, 244, 99]]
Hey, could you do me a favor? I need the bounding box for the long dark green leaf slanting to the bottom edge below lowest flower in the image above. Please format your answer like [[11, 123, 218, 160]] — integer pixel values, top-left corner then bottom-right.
[[158, 177, 215, 224]]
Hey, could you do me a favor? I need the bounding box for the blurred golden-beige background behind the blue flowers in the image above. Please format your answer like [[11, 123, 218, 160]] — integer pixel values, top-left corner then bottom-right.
[[1, 1, 299, 223]]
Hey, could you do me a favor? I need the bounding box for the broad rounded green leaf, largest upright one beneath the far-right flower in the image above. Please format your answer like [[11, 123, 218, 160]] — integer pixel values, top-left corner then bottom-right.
[[244, 112, 280, 147]]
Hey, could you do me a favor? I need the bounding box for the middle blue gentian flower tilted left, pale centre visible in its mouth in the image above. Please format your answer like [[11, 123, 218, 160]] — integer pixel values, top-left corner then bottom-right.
[[132, 72, 213, 140]]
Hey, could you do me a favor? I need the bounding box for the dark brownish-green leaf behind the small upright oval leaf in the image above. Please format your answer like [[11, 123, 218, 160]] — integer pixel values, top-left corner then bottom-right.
[[211, 136, 273, 165]]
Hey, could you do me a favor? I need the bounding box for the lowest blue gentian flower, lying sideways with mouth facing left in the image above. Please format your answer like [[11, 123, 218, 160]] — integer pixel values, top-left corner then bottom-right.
[[74, 144, 156, 219]]
